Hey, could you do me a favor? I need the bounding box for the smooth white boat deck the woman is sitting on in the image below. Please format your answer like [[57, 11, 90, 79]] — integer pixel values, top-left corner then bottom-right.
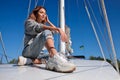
[[0, 59, 120, 80]]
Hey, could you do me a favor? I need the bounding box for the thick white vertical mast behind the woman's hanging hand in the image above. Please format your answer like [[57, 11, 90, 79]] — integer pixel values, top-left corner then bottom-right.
[[59, 0, 65, 53]]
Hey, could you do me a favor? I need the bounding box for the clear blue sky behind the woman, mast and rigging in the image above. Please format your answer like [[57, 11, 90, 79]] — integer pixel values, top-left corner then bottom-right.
[[0, 0, 120, 60]]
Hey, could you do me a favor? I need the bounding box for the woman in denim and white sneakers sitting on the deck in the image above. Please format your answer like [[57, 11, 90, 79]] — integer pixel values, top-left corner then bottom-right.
[[18, 6, 75, 72]]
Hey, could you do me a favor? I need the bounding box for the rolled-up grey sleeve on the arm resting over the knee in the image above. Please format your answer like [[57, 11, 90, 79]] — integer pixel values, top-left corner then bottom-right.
[[25, 19, 43, 35]]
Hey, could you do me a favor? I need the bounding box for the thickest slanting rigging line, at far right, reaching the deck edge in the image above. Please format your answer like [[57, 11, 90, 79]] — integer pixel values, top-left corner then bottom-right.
[[100, 0, 119, 73]]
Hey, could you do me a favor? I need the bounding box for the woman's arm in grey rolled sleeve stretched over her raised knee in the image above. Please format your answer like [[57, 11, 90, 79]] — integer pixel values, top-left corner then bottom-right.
[[25, 20, 68, 42]]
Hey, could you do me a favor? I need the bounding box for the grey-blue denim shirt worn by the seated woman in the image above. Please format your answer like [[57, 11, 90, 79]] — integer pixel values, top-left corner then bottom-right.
[[24, 19, 43, 47]]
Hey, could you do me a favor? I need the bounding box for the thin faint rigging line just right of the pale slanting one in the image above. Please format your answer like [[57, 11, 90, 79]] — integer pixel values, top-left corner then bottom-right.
[[87, 0, 110, 58]]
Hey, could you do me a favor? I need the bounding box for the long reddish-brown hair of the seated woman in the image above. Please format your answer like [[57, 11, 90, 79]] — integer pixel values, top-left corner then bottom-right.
[[28, 6, 46, 24]]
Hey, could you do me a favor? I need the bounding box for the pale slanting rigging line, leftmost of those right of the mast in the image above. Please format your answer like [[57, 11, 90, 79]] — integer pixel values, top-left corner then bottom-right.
[[84, 0, 106, 61]]
